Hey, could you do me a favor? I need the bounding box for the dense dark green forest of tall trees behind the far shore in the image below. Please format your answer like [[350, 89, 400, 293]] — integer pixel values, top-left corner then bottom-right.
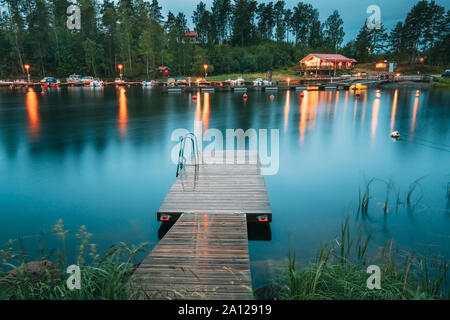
[[0, 0, 450, 78]]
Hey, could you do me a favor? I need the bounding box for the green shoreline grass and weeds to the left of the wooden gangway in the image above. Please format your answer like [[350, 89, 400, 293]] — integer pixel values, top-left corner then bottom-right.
[[0, 221, 146, 300]]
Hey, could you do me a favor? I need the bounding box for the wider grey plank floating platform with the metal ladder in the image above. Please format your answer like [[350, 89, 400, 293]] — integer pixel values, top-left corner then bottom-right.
[[158, 151, 272, 221]]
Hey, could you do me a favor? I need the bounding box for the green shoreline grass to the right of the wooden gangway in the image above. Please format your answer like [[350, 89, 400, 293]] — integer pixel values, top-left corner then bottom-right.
[[273, 219, 450, 300]]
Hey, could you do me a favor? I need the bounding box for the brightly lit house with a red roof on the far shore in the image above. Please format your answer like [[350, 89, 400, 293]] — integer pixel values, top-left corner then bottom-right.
[[300, 53, 357, 71]]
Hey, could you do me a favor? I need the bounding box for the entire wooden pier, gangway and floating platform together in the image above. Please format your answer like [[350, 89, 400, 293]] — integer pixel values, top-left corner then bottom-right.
[[133, 151, 272, 300]]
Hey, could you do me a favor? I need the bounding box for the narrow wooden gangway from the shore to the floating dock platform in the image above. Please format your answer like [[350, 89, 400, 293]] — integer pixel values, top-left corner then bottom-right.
[[133, 213, 253, 300]]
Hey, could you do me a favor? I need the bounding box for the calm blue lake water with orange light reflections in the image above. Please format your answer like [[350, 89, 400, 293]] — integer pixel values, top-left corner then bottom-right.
[[0, 88, 450, 285]]
